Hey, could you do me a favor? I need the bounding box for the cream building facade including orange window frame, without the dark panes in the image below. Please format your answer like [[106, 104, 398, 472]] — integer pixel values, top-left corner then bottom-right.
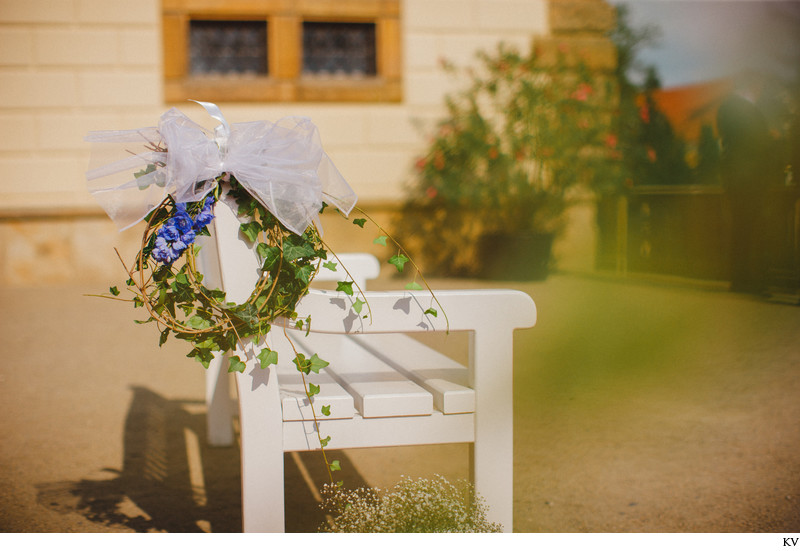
[[0, 0, 614, 286]]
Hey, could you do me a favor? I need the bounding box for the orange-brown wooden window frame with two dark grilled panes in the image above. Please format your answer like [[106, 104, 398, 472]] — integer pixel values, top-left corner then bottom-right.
[[160, 0, 403, 102]]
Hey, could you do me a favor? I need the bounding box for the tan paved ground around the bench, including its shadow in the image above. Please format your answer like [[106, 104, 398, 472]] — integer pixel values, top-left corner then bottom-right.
[[0, 276, 800, 532]]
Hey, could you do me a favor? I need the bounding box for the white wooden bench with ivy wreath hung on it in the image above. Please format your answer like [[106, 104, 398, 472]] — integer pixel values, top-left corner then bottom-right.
[[200, 198, 536, 532]]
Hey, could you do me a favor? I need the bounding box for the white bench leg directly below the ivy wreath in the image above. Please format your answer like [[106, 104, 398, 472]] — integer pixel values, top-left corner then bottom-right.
[[236, 348, 285, 532]]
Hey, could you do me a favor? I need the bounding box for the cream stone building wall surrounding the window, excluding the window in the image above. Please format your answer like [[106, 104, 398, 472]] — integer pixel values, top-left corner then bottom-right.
[[0, 0, 613, 286]]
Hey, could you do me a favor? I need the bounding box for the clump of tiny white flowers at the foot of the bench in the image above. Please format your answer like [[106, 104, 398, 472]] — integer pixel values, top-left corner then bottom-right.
[[320, 475, 502, 532]]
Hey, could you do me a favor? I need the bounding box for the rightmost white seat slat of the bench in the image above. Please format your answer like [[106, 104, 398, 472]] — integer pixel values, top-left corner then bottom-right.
[[351, 334, 475, 414]]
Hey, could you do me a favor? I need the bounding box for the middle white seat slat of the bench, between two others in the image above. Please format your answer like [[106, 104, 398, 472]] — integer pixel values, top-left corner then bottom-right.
[[296, 333, 433, 418]]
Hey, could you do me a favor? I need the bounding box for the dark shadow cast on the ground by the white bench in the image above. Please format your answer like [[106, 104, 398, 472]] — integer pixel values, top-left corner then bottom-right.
[[37, 387, 366, 533]]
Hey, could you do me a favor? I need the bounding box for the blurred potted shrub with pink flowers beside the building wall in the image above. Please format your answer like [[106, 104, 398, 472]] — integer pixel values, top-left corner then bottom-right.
[[399, 44, 614, 279]]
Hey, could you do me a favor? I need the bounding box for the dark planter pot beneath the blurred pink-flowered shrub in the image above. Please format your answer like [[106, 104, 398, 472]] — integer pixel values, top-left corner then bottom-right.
[[478, 233, 553, 281]]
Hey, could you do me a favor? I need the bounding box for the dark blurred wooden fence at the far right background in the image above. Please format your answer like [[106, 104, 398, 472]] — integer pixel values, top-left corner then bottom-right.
[[597, 186, 800, 296]]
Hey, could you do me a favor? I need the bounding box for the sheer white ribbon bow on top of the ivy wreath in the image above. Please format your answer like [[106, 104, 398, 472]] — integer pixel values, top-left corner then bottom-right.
[[86, 102, 357, 234]]
